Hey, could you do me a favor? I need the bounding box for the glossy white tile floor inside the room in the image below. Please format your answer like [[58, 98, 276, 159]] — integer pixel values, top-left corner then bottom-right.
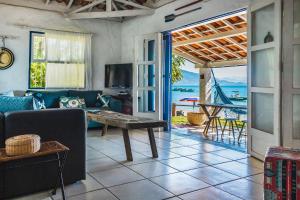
[[12, 129, 263, 200]]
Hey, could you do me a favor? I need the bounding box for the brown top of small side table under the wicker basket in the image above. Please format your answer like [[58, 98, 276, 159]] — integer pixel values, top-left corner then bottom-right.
[[0, 141, 69, 163]]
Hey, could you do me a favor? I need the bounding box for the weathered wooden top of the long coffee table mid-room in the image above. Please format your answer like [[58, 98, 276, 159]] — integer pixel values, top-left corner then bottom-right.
[[87, 110, 167, 129]]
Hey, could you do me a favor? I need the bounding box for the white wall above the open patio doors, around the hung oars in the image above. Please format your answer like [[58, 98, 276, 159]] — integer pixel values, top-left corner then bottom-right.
[[122, 0, 249, 62]]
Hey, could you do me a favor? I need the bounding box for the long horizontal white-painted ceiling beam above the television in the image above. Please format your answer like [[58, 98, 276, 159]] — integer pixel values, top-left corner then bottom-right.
[[69, 9, 154, 19]]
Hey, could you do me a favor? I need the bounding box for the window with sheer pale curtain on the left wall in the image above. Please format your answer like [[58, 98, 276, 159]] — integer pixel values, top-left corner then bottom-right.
[[29, 32, 90, 89]]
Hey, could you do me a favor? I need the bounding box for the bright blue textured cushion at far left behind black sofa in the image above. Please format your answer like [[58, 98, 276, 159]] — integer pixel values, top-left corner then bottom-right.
[[0, 96, 33, 113]]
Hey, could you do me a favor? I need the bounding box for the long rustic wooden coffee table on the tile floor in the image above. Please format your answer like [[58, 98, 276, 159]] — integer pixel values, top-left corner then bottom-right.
[[87, 111, 167, 161]]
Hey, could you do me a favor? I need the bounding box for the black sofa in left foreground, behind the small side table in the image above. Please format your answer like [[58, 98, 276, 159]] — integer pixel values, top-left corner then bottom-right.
[[0, 109, 86, 198]]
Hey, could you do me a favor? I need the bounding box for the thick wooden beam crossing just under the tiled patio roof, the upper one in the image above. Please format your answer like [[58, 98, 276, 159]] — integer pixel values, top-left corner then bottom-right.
[[173, 28, 247, 48]]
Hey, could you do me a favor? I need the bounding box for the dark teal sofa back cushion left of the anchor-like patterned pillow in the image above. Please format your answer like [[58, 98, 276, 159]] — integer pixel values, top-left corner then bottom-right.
[[69, 90, 102, 107]]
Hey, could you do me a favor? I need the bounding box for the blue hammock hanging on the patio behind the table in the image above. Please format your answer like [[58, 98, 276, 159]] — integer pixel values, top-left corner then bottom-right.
[[210, 69, 247, 117]]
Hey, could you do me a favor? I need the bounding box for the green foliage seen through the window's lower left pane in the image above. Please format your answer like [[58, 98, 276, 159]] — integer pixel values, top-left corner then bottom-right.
[[30, 62, 47, 88]]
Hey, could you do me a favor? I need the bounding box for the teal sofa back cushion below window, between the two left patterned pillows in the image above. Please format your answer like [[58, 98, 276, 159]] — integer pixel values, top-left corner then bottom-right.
[[27, 90, 69, 108]]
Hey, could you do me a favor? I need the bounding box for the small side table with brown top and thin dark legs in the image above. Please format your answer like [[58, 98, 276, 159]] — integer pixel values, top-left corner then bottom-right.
[[0, 141, 69, 200]]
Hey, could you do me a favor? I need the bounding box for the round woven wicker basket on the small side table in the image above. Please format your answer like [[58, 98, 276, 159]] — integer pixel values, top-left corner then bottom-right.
[[5, 134, 41, 156]]
